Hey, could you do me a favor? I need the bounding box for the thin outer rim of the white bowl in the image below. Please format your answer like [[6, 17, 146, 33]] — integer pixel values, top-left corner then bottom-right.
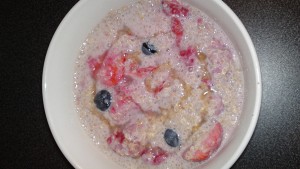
[[42, 0, 262, 169]]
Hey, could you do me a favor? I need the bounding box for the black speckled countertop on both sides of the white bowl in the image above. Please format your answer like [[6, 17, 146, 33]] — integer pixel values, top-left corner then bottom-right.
[[0, 0, 300, 169]]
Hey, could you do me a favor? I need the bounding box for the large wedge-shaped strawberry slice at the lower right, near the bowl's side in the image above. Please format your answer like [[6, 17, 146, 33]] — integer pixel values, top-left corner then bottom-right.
[[182, 122, 223, 162]]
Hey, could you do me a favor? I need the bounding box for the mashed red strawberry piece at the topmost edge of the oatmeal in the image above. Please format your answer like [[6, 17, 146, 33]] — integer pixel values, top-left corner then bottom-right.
[[161, 0, 189, 16]]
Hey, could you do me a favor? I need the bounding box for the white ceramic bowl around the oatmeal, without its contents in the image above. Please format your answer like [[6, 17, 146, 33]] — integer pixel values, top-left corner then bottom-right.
[[42, 0, 261, 169]]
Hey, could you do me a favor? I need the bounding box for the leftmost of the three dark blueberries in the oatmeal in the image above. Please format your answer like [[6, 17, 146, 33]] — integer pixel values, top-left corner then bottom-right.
[[94, 90, 111, 111]]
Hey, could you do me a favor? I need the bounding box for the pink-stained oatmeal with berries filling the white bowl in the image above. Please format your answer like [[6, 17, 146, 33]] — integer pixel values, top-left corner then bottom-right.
[[74, 0, 244, 168]]
